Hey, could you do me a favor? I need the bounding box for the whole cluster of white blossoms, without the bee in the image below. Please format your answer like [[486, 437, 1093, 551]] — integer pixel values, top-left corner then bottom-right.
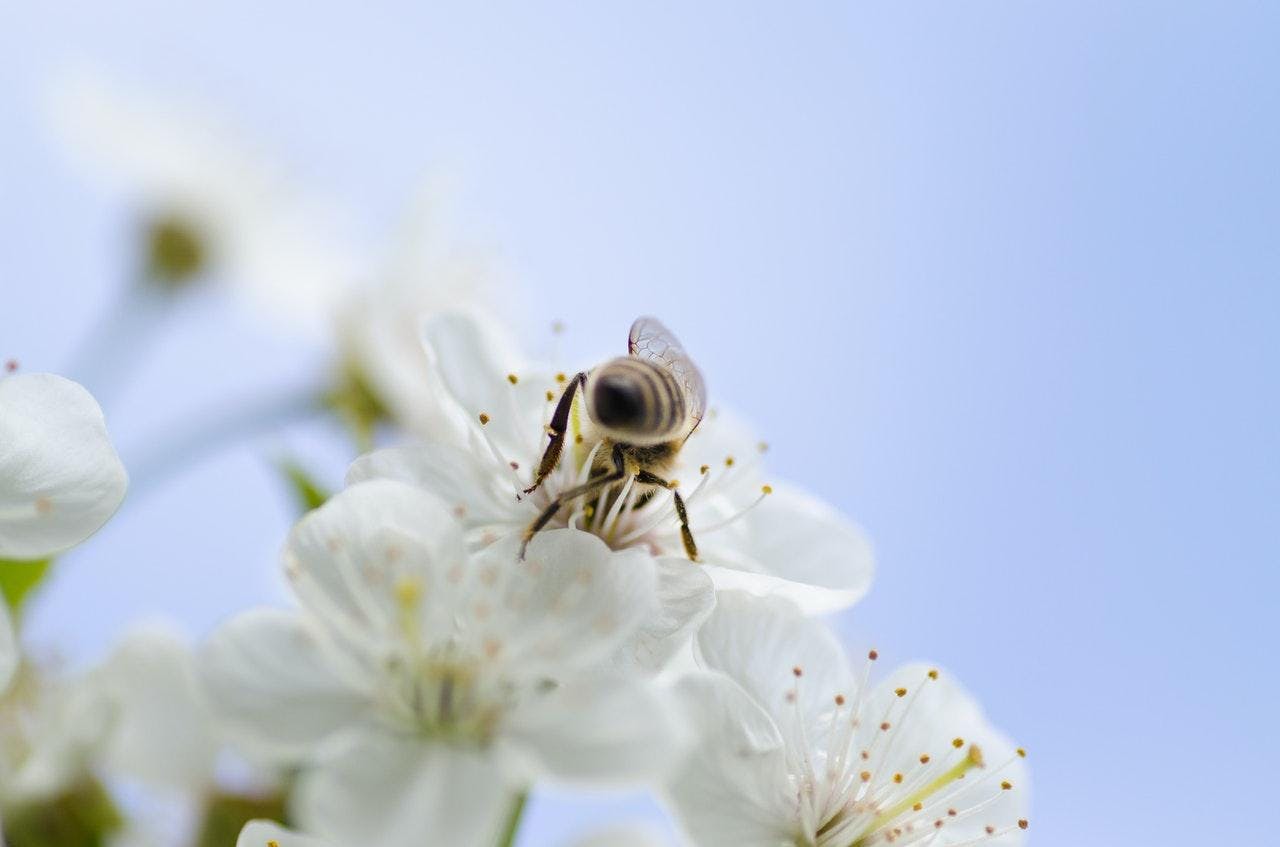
[[0, 71, 1028, 847]]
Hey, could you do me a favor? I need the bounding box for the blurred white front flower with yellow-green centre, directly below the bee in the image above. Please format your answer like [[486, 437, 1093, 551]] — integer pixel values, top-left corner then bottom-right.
[[204, 480, 680, 847]]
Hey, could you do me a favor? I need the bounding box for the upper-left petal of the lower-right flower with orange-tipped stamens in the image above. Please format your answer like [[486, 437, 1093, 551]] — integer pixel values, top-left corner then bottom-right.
[[698, 591, 855, 724]]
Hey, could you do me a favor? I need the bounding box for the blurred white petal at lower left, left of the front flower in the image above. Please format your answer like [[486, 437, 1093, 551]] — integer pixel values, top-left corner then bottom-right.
[[96, 629, 219, 792]]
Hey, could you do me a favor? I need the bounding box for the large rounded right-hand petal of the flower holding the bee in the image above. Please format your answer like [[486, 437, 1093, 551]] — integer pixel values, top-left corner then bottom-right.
[[700, 484, 876, 614]]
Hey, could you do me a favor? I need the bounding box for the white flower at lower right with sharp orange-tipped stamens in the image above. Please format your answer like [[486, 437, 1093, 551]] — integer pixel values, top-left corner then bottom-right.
[[668, 592, 1027, 847]]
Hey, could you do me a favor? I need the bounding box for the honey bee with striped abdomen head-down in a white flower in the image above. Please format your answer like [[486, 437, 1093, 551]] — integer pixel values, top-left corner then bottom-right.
[[520, 317, 707, 562]]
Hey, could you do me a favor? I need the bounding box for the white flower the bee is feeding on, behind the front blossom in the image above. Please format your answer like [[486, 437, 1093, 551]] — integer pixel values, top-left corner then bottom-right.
[[348, 312, 873, 612]]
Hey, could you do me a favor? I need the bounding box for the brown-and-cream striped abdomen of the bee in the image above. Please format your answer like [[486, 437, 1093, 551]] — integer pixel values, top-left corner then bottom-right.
[[586, 357, 689, 444]]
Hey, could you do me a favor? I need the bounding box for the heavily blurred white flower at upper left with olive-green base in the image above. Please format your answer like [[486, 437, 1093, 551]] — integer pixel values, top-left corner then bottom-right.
[[51, 73, 358, 331]]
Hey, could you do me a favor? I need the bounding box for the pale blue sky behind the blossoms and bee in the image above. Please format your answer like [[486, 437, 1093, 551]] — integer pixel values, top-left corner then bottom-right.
[[0, 0, 1280, 846]]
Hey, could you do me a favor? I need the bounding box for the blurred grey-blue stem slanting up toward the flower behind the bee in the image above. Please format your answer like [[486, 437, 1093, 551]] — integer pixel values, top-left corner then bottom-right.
[[127, 388, 324, 498]]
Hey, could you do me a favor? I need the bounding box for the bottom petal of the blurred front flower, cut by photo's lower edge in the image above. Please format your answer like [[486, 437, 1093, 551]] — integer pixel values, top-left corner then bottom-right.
[[294, 728, 515, 847]]
